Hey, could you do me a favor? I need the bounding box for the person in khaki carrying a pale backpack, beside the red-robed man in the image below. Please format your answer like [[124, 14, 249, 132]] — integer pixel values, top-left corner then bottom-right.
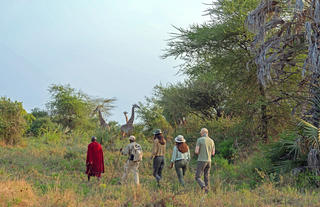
[[120, 136, 142, 185]]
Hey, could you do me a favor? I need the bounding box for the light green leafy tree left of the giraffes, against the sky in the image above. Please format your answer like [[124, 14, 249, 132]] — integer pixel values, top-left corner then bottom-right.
[[48, 85, 94, 130]]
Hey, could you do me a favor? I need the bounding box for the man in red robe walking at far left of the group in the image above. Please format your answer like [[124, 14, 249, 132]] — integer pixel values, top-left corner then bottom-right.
[[86, 137, 104, 181]]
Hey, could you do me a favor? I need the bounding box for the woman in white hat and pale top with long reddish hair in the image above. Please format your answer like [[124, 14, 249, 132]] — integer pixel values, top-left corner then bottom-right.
[[170, 135, 190, 186]]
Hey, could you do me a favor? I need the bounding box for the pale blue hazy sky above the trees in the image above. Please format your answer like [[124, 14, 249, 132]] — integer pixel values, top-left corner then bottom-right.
[[0, 0, 211, 123]]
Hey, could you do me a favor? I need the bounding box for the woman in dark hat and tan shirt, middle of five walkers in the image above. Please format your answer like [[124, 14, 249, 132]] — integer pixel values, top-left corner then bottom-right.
[[151, 129, 166, 186]]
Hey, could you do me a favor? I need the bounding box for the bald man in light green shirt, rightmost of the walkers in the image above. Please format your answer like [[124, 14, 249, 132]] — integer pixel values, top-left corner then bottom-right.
[[195, 128, 215, 193]]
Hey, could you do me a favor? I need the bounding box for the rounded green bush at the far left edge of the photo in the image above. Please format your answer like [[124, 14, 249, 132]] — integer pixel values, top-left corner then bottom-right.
[[0, 97, 27, 144]]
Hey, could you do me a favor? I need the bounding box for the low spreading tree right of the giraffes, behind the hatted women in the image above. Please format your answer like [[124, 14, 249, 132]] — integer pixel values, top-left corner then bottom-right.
[[155, 77, 227, 125]]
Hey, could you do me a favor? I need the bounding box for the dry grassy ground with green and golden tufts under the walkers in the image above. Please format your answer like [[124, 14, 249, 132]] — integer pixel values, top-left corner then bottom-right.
[[0, 135, 320, 207]]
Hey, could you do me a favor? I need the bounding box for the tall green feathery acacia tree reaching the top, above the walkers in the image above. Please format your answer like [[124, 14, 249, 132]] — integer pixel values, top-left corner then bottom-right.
[[164, 0, 278, 141]]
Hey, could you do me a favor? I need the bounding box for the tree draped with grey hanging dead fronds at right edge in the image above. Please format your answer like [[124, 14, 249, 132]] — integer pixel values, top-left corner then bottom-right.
[[247, 0, 320, 126]]
